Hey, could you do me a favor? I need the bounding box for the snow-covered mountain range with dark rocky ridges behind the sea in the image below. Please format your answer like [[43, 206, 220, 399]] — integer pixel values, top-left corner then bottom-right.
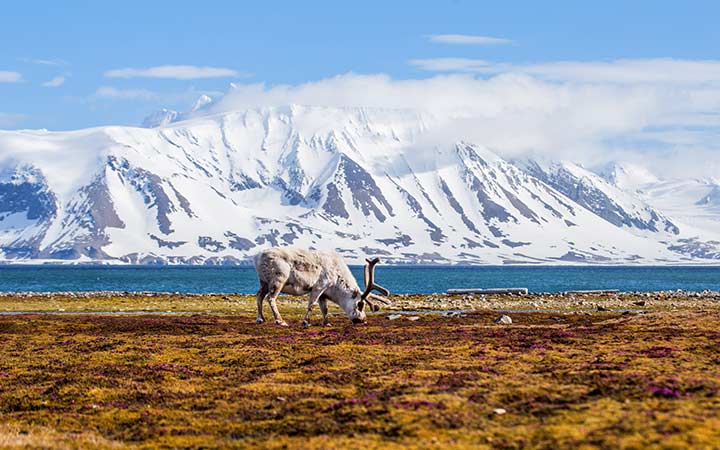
[[0, 104, 720, 264]]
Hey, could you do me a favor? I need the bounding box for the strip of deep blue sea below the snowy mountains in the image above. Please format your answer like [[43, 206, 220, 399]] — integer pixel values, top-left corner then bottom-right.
[[0, 266, 720, 294]]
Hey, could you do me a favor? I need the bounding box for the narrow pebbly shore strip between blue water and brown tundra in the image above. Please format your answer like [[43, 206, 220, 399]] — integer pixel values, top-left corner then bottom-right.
[[0, 291, 720, 315]]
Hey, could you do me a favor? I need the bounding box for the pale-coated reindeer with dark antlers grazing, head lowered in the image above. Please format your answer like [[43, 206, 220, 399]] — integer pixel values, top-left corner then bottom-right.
[[255, 247, 390, 326]]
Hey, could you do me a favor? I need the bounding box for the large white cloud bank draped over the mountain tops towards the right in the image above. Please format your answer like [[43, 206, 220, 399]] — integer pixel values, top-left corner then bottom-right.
[[212, 68, 720, 175]]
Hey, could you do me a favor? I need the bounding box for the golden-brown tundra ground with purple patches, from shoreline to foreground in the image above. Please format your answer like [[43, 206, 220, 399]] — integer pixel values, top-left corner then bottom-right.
[[0, 294, 720, 449]]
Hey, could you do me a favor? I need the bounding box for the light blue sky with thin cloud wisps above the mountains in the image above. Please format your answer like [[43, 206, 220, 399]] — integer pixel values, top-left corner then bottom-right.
[[0, 0, 720, 130]]
